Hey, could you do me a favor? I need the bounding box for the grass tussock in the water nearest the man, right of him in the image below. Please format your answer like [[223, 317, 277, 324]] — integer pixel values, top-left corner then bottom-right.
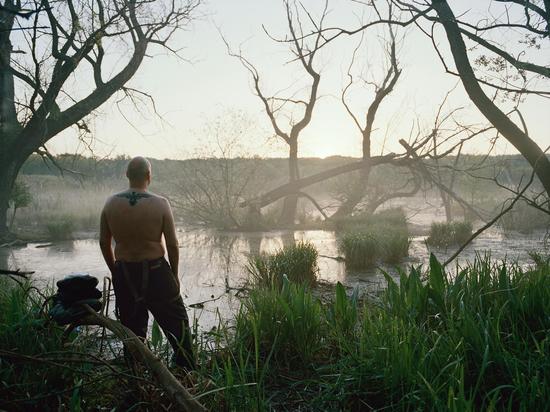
[[246, 242, 319, 287]]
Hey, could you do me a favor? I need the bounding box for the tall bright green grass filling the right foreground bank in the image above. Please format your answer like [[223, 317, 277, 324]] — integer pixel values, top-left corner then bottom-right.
[[198, 256, 550, 411]]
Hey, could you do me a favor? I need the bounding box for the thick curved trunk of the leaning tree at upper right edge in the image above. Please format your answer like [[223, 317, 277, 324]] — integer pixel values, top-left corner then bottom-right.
[[432, 0, 550, 196]]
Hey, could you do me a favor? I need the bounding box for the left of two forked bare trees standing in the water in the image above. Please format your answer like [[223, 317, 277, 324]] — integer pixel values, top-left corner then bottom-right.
[[224, 0, 328, 225]]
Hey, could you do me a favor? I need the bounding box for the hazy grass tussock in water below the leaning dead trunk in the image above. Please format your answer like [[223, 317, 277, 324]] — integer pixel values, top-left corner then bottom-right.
[[338, 209, 409, 269]]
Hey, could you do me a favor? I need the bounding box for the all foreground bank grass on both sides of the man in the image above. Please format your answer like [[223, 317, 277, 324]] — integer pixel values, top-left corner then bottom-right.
[[0, 255, 550, 411]]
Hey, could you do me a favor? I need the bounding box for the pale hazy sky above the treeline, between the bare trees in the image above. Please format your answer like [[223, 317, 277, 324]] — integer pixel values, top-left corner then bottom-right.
[[48, 0, 550, 159]]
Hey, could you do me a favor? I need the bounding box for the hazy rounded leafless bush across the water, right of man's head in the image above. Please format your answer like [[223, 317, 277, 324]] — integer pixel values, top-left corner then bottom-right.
[[171, 111, 266, 229]]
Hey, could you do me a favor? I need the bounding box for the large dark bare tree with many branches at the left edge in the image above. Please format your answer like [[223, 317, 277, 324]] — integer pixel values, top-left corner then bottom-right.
[[0, 0, 200, 236]]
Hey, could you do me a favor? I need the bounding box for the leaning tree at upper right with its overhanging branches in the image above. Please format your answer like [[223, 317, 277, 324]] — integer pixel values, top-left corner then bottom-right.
[[316, 0, 550, 196]]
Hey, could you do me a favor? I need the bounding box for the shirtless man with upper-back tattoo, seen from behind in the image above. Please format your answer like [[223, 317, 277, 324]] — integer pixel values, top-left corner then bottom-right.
[[99, 157, 195, 370]]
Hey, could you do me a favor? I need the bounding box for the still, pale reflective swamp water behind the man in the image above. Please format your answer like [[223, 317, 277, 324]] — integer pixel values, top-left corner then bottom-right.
[[0, 228, 548, 330]]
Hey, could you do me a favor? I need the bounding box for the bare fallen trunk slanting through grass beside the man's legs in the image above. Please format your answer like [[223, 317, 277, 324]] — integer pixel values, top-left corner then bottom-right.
[[79, 305, 207, 412]]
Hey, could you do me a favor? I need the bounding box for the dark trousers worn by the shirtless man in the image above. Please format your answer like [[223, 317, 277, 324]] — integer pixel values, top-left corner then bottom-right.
[[113, 258, 195, 369]]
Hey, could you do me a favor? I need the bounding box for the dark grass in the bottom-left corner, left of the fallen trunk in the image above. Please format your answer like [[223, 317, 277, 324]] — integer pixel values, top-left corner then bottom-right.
[[0, 278, 185, 412]]
